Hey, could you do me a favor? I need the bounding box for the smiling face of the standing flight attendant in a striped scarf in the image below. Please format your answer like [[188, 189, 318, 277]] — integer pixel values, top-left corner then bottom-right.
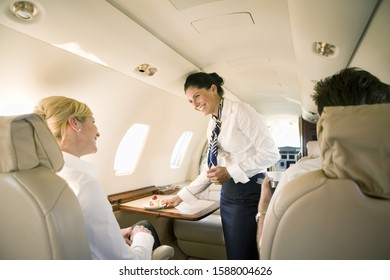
[[185, 85, 221, 116]]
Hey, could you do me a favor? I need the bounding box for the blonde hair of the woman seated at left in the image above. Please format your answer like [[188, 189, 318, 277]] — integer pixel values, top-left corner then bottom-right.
[[34, 96, 93, 143]]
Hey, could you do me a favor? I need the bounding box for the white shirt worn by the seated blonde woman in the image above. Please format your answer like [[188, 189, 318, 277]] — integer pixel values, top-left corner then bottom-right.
[[58, 152, 154, 260]]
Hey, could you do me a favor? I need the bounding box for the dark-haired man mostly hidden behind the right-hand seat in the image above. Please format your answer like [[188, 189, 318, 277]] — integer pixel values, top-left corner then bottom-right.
[[257, 68, 390, 252]]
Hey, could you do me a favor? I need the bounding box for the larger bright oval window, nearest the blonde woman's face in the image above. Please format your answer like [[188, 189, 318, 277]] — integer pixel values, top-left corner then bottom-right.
[[114, 124, 149, 176]]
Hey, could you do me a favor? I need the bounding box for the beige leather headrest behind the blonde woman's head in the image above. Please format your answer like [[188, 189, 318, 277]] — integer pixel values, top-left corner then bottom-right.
[[0, 114, 64, 173]]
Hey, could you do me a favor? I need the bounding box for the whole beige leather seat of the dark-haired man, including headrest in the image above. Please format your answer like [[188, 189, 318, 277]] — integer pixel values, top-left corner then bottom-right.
[[260, 104, 390, 260]]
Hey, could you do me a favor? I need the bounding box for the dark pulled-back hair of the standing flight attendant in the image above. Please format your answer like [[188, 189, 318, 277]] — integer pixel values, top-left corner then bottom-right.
[[184, 72, 224, 97]]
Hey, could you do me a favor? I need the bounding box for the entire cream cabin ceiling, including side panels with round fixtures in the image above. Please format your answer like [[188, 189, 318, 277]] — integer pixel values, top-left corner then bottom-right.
[[0, 0, 390, 121]]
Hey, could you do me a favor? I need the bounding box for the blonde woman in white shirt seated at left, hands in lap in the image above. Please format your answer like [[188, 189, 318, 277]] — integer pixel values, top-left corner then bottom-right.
[[34, 96, 159, 259]]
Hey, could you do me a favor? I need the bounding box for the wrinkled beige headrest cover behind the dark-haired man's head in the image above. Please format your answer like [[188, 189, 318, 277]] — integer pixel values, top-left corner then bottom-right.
[[317, 104, 390, 199]]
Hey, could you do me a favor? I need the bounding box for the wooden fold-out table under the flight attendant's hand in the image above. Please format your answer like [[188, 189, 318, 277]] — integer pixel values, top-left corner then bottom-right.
[[119, 195, 219, 221]]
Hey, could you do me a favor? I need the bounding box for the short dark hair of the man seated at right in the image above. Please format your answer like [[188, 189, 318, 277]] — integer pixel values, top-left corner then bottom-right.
[[312, 67, 390, 114]]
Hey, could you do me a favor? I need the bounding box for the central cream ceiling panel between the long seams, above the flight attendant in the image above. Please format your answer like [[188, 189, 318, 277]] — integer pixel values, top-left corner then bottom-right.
[[109, 0, 300, 115]]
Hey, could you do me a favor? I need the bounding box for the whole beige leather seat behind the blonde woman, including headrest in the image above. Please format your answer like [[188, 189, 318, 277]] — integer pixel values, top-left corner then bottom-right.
[[0, 114, 91, 259]]
